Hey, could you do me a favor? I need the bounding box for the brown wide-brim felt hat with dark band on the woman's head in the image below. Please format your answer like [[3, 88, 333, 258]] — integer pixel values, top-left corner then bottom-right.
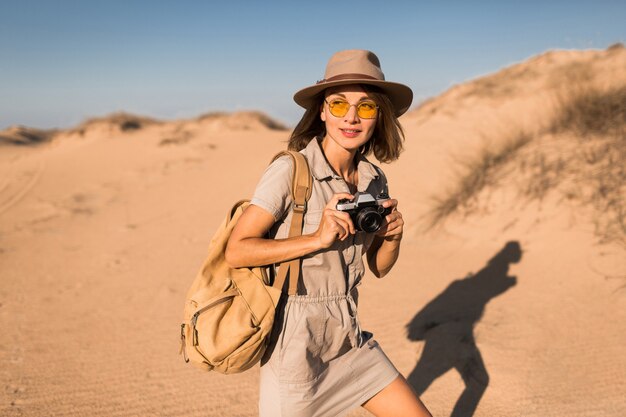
[[293, 49, 413, 117]]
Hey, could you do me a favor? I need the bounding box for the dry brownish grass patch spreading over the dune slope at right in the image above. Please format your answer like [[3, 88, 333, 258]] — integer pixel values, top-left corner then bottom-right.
[[428, 84, 626, 246]]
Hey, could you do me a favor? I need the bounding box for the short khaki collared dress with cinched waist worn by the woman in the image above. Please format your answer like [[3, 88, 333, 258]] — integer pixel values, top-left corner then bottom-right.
[[252, 139, 399, 417]]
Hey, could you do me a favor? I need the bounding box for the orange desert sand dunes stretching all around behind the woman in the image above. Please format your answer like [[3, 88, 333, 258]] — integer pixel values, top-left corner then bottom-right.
[[0, 47, 626, 417]]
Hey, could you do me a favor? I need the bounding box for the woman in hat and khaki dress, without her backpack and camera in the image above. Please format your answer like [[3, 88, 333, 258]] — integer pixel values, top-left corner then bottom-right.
[[226, 50, 430, 417]]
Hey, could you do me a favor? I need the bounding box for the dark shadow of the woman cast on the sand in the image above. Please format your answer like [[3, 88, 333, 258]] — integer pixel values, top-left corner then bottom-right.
[[407, 241, 522, 417]]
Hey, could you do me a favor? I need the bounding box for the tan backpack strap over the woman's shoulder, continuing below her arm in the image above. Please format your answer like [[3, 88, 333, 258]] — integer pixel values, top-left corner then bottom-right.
[[272, 151, 313, 295]]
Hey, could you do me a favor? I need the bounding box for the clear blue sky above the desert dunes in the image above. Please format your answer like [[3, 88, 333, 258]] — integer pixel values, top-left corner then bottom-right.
[[0, 0, 626, 129]]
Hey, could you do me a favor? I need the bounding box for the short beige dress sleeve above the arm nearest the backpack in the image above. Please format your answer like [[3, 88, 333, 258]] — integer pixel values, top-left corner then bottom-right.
[[250, 156, 293, 221]]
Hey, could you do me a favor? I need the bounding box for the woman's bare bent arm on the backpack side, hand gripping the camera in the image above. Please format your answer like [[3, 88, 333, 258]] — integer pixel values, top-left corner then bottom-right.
[[225, 193, 354, 268]]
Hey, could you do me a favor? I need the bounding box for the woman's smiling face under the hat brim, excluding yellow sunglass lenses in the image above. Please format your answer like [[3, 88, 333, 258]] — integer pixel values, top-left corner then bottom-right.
[[320, 84, 378, 151]]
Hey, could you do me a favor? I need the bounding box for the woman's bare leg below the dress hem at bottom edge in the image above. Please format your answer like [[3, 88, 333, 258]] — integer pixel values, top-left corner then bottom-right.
[[363, 375, 432, 417]]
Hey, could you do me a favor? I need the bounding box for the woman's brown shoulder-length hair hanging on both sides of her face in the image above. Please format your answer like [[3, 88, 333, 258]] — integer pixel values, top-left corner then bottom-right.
[[288, 85, 404, 162]]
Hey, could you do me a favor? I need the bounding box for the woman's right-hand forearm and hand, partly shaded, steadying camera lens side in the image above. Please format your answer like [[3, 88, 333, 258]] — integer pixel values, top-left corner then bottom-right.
[[367, 199, 404, 278]]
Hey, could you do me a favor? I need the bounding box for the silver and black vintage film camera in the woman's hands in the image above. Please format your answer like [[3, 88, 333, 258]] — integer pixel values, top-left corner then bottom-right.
[[337, 192, 391, 233]]
